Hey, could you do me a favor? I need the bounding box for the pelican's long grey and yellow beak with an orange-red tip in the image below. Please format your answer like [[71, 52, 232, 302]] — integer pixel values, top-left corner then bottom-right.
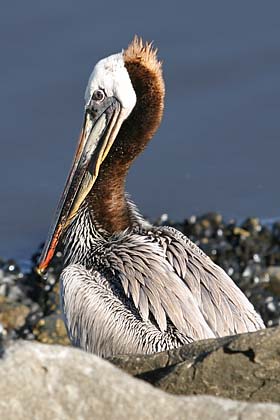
[[37, 97, 124, 275]]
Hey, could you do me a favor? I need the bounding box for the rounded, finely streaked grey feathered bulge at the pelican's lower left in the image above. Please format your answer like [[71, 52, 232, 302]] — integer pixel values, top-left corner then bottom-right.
[[60, 264, 170, 357]]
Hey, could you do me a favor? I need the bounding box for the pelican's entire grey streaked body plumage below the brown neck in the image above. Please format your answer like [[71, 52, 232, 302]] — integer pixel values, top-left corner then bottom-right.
[[60, 202, 264, 357]]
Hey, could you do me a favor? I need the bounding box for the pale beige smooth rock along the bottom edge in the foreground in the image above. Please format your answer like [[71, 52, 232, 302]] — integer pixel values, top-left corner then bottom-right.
[[0, 341, 280, 420]]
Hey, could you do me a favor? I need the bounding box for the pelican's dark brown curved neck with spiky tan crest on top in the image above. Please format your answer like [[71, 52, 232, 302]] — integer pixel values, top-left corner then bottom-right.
[[89, 37, 164, 233]]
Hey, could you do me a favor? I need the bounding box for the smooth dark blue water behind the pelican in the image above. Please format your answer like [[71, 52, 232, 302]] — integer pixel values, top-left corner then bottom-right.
[[0, 0, 280, 258]]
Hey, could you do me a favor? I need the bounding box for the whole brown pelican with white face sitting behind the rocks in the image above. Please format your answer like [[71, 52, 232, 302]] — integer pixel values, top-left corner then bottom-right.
[[38, 37, 264, 357]]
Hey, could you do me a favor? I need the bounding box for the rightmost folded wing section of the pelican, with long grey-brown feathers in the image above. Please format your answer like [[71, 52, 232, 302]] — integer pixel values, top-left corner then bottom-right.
[[155, 227, 265, 336]]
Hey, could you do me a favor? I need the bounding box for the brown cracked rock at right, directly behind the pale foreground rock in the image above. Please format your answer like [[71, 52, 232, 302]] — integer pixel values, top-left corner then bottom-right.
[[109, 328, 280, 402]]
